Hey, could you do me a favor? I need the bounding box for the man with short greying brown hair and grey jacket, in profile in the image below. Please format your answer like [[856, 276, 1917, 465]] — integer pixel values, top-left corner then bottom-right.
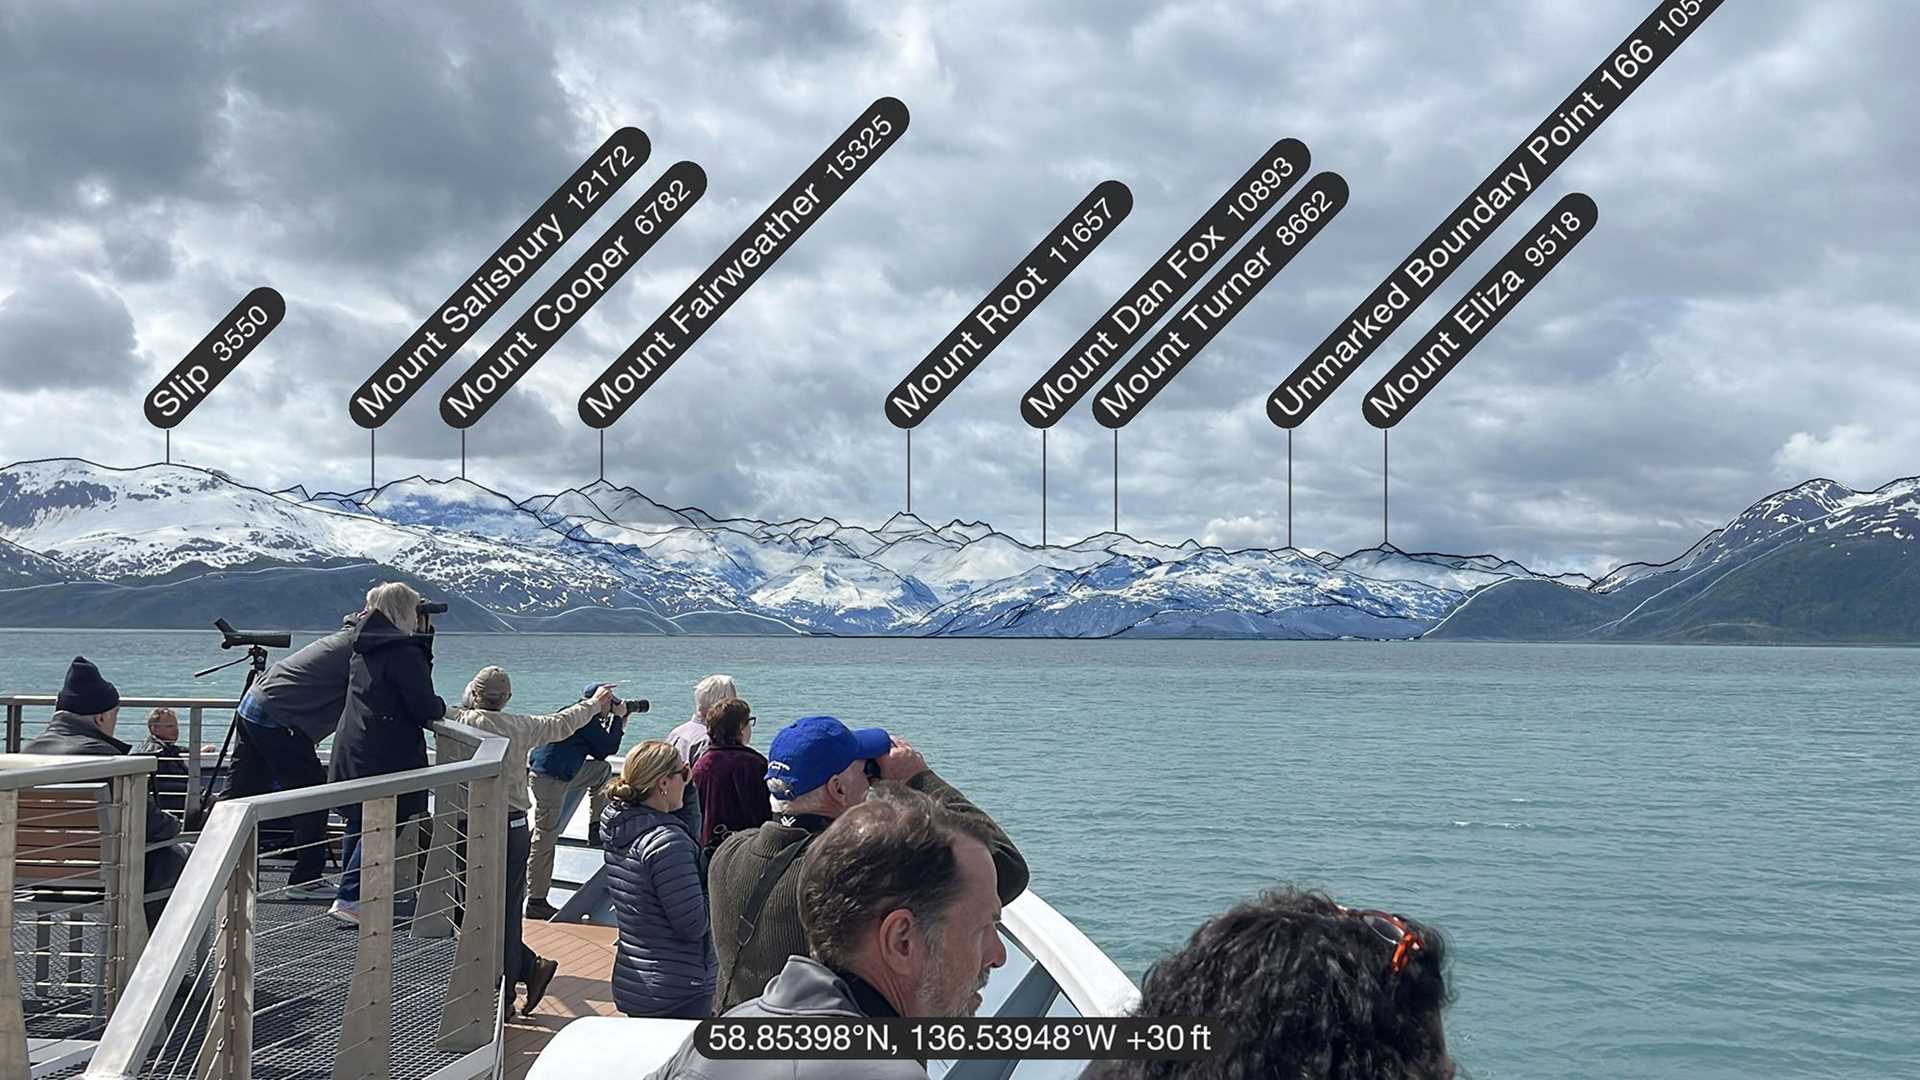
[[649, 784, 1013, 1080]]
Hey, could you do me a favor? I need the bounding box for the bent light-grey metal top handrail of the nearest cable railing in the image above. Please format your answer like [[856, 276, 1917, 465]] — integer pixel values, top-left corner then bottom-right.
[[86, 714, 509, 1080]]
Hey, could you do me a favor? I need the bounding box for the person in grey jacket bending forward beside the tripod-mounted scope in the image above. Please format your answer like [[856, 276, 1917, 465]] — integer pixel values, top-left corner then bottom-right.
[[221, 615, 359, 899]]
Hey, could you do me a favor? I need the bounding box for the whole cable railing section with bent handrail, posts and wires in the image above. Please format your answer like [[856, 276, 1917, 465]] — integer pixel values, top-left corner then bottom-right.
[[84, 723, 509, 1080]]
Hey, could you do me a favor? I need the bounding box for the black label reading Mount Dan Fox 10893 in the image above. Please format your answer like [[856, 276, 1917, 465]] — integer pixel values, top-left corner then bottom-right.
[[1020, 138, 1313, 429]]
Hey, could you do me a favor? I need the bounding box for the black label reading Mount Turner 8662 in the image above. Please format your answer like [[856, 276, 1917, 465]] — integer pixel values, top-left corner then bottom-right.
[[1092, 173, 1348, 430]]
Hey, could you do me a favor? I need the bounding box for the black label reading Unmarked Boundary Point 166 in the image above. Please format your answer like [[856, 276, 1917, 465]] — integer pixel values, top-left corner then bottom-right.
[[1267, 0, 1722, 429]]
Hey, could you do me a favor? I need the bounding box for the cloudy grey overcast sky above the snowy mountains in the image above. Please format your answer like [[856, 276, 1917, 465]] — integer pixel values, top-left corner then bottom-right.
[[0, 0, 1920, 569]]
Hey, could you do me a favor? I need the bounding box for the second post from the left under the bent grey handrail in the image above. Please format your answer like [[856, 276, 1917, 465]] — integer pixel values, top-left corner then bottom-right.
[[334, 796, 396, 1080]]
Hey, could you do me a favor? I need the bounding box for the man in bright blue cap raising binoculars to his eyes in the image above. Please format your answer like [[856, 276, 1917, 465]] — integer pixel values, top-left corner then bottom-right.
[[708, 717, 1027, 1013]]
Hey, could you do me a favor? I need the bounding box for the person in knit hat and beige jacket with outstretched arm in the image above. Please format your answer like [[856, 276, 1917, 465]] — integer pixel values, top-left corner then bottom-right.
[[447, 665, 612, 1013]]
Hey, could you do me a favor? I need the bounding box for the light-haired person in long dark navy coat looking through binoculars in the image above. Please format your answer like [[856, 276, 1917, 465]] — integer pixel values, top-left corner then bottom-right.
[[328, 582, 447, 922]]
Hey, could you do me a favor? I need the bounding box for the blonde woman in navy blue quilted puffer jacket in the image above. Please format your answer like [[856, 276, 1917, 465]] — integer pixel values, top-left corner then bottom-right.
[[601, 740, 716, 1020]]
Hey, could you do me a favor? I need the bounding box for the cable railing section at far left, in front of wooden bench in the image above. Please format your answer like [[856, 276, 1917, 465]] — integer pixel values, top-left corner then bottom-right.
[[0, 753, 154, 1076]]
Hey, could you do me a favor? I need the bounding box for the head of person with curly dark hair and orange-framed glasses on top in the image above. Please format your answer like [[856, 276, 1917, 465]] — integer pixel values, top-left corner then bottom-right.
[[1081, 888, 1453, 1080]]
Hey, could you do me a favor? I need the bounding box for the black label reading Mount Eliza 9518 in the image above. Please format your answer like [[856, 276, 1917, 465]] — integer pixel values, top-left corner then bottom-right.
[[1359, 192, 1599, 430]]
